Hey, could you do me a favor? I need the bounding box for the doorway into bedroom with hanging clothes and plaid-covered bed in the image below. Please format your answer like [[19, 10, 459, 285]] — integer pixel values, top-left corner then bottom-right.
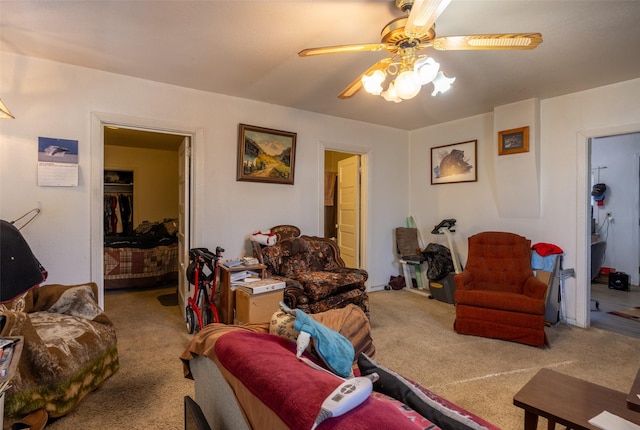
[[102, 126, 186, 306]]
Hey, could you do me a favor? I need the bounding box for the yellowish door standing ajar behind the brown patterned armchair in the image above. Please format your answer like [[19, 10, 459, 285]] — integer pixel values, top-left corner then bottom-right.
[[338, 155, 360, 267]]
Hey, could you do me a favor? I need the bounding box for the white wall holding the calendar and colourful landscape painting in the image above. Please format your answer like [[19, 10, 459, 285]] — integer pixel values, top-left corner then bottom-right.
[[0, 53, 409, 287]]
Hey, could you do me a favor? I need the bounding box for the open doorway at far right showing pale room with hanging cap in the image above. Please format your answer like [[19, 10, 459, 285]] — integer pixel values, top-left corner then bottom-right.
[[589, 133, 640, 338]]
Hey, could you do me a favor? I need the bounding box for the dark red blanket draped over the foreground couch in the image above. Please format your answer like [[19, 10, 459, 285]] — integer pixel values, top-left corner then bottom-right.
[[215, 331, 437, 430]]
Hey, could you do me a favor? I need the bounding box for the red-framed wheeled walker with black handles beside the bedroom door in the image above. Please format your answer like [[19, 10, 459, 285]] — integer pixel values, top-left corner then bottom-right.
[[185, 246, 224, 334]]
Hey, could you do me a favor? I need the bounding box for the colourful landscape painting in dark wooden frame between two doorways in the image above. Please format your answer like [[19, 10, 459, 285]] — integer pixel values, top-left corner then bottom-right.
[[236, 124, 296, 185]]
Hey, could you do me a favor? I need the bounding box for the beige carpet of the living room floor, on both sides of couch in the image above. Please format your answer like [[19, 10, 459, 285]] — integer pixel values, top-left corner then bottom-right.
[[41, 288, 640, 430]]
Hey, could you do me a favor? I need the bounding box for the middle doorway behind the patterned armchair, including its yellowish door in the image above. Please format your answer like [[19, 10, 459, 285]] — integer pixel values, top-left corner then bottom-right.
[[324, 150, 367, 269]]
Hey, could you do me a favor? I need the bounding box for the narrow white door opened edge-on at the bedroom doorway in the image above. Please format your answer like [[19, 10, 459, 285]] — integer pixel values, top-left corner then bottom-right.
[[178, 137, 191, 313]]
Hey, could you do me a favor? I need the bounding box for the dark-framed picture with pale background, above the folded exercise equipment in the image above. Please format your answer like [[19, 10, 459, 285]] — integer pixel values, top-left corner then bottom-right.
[[431, 140, 478, 185]]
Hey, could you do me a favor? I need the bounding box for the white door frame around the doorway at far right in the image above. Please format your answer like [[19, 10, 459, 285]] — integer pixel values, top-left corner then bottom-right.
[[571, 123, 640, 328]]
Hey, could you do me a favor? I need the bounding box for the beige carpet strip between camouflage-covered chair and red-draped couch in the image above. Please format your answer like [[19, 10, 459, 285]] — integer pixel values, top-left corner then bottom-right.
[[47, 287, 194, 430]]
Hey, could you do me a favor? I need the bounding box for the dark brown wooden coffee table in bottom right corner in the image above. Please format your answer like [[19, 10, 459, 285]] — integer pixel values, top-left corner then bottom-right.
[[513, 369, 640, 430]]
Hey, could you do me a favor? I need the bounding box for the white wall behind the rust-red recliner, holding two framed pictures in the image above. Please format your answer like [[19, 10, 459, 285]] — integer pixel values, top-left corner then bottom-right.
[[410, 79, 640, 326]]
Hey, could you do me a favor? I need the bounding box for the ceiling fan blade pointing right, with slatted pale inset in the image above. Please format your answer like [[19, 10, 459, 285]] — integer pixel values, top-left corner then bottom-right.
[[433, 33, 542, 51]]
